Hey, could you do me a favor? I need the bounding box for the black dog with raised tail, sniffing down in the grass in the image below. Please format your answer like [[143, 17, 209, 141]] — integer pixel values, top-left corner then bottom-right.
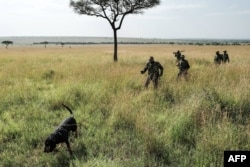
[[44, 104, 77, 155]]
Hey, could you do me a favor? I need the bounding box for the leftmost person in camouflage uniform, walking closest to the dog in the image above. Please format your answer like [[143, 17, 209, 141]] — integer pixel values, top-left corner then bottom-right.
[[141, 56, 163, 89]]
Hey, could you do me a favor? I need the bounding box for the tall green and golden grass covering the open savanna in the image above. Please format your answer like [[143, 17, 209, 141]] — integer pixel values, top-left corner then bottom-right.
[[0, 45, 250, 167]]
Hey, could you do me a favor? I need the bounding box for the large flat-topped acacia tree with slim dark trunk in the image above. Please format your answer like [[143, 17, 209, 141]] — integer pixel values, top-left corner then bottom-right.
[[70, 0, 160, 62]]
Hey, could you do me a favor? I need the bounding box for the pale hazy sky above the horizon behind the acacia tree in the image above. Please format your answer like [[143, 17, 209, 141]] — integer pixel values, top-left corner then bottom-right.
[[0, 0, 250, 39]]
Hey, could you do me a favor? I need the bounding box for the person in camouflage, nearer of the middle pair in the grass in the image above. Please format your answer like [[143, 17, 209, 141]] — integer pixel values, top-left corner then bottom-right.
[[176, 55, 190, 81]]
